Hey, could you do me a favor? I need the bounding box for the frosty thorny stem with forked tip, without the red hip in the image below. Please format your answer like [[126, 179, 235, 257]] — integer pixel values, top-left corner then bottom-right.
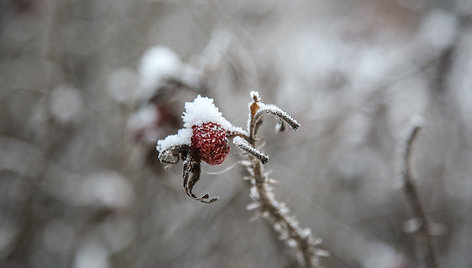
[[242, 91, 328, 267]]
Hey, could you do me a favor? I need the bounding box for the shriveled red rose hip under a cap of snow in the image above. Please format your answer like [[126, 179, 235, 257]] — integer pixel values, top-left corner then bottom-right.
[[191, 122, 231, 165]]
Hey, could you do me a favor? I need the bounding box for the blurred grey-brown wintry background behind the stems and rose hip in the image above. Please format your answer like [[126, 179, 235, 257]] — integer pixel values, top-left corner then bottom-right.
[[0, 0, 472, 268]]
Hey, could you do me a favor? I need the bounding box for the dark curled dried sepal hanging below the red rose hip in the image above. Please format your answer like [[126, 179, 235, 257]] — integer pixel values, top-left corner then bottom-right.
[[183, 154, 218, 204]]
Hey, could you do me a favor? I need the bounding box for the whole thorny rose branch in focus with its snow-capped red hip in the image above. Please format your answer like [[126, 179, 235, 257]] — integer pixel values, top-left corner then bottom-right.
[[156, 91, 329, 267]]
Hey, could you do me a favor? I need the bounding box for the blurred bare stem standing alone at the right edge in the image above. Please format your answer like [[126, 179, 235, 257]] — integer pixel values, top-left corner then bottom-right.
[[402, 118, 440, 268]]
